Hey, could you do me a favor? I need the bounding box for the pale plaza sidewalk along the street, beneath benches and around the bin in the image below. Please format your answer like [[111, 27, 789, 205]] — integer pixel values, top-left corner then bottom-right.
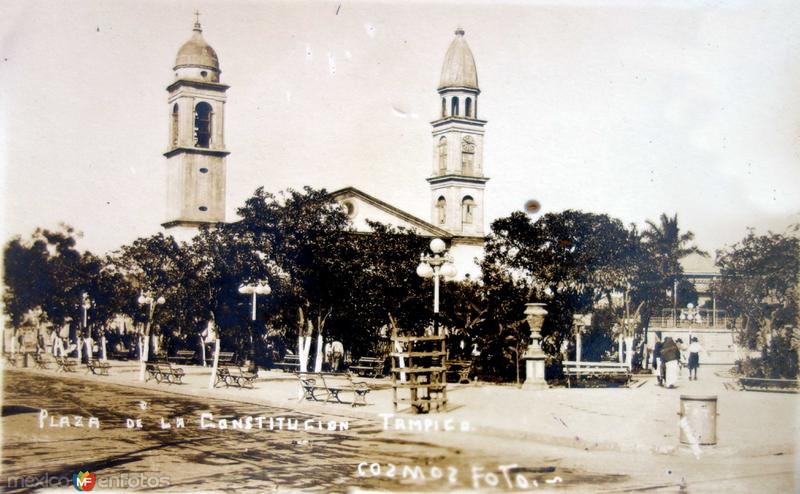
[[4, 361, 800, 456]]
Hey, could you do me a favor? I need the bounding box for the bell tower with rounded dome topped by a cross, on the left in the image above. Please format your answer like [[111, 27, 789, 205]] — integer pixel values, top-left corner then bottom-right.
[[162, 14, 230, 240]]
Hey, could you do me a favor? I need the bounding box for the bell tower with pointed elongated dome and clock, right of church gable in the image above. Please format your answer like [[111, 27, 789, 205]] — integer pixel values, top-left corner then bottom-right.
[[427, 28, 489, 239]]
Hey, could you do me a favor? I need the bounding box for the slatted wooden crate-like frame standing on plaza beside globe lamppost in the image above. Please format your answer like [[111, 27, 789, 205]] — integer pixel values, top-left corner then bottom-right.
[[390, 330, 447, 413]]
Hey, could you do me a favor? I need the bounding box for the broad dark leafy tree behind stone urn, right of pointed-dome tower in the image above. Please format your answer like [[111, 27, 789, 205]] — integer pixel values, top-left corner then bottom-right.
[[483, 210, 636, 366]]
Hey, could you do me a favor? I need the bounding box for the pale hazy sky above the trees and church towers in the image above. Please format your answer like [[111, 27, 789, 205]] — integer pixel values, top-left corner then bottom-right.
[[0, 0, 800, 253]]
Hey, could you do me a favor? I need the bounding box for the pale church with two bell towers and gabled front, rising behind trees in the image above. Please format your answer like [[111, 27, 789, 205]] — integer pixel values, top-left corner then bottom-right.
[[162, 22, 489, 279]]
